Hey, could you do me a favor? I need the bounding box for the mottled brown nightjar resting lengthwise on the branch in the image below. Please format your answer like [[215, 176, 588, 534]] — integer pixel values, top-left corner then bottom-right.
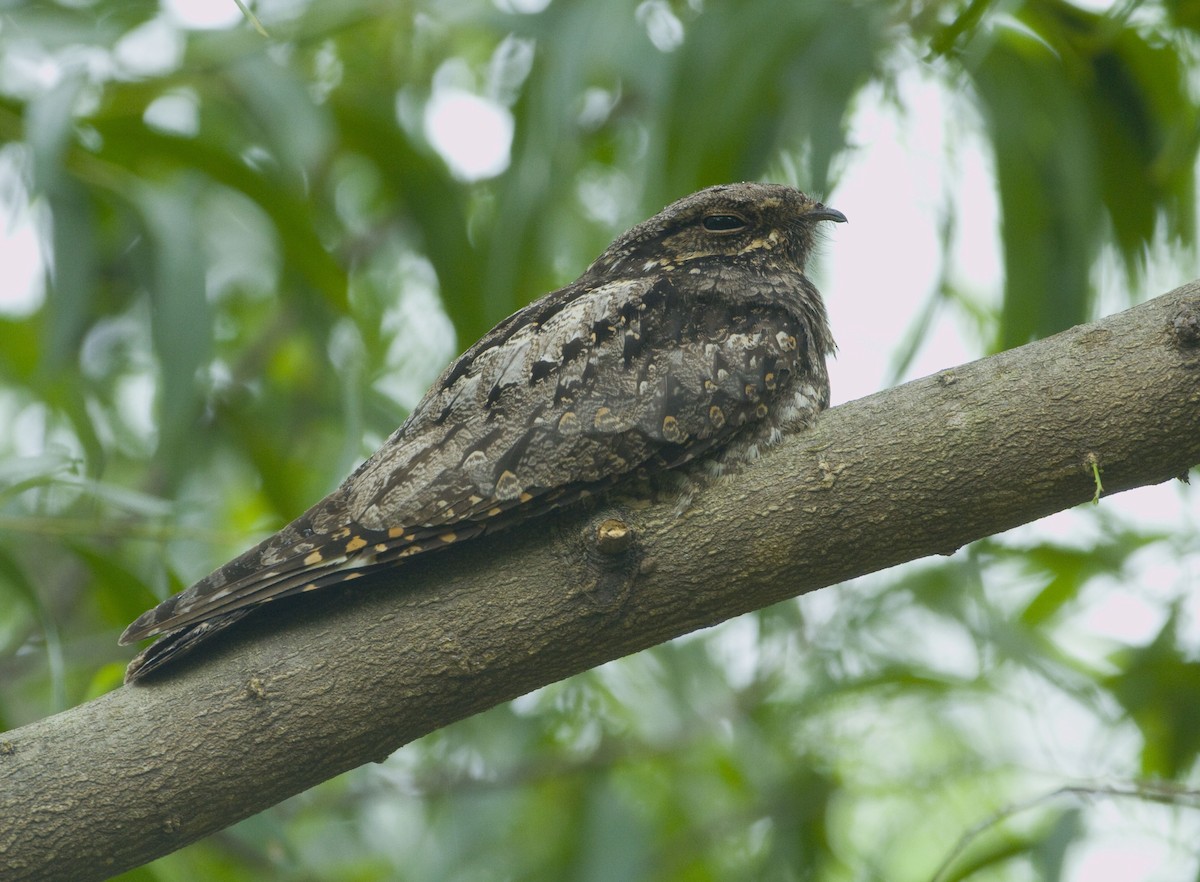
[[121, 184, 846, 682]]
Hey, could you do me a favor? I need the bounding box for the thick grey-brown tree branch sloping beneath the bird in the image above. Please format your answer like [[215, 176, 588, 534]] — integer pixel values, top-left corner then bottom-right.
[[7, 283, 1200, 880]]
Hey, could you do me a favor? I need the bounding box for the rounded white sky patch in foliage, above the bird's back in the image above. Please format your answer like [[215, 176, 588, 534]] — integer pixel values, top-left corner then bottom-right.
[[425, 86, 512, 181]]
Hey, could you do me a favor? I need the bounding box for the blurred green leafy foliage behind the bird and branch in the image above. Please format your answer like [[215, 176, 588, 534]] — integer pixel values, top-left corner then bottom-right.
[[0, 0, 1200, 882]]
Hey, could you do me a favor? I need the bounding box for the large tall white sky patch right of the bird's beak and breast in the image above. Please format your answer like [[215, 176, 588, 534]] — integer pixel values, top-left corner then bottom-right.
[[821, 73, 984, 404]]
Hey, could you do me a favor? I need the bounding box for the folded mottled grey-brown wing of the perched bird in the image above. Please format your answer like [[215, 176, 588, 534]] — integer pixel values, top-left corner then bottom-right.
[[121, 276, 812, 676]]
